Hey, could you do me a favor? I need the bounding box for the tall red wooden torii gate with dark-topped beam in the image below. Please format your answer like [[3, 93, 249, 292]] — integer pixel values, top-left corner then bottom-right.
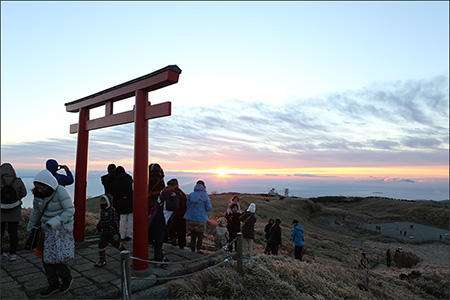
[[65, 65, 181, 270]]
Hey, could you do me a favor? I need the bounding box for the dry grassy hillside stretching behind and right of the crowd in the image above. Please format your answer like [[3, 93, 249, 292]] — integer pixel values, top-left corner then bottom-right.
[[9, 194, 449, 299]]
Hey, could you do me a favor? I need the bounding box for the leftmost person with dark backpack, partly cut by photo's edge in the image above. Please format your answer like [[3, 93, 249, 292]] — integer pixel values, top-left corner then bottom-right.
[[1, 163, 27, 261]]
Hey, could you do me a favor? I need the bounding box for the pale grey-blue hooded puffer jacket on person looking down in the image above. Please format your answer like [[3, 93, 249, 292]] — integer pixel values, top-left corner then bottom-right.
[[27, 170, 75, 233]]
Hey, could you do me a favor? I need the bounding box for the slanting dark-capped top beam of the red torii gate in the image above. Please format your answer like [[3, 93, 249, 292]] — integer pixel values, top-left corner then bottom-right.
[[65, 65, 181, 112]]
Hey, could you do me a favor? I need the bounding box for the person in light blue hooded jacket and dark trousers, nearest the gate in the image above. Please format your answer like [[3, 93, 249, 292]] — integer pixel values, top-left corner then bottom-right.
[[184, 180, 212, 254]]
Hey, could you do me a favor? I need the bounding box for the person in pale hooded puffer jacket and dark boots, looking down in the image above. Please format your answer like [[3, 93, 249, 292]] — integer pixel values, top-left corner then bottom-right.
[[27, 170, 75, 297]]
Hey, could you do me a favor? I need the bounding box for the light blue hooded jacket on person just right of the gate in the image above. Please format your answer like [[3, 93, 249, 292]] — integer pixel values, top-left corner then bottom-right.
[[184, 184, 212, 222]]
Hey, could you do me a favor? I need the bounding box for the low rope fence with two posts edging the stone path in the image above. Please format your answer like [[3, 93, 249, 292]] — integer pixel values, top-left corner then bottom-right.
[[120, 232, 243, 299]]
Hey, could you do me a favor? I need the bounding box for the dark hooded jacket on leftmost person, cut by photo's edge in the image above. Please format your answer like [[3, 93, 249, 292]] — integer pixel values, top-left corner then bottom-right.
[[1, 163, 27, 222]]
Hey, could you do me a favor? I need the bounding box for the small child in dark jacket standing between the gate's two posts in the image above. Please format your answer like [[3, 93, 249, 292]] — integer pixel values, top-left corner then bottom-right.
[[94, 194, 126, 267]]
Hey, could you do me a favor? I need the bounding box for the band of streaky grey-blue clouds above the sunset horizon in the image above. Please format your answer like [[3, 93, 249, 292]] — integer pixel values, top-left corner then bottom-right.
[[2, 76, 449, 173]]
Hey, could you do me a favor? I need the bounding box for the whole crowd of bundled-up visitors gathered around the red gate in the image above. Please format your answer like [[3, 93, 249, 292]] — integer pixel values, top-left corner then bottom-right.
[[1, 159, 304, 297]]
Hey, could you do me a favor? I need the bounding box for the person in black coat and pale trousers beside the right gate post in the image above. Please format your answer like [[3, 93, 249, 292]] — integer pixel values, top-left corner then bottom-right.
[[112, 166, 133, 241]]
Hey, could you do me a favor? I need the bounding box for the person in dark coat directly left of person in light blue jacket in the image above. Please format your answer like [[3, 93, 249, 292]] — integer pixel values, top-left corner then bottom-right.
[[167, 178, 187, 249]]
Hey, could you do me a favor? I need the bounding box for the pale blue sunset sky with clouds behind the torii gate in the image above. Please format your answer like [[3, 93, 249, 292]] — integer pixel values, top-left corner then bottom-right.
[[1, 1, 449, 199]]
